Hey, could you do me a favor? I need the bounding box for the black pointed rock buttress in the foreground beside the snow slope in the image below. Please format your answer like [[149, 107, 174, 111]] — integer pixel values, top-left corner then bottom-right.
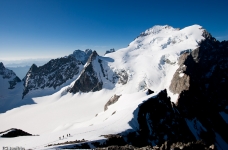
[[114, 90, 221, 150]]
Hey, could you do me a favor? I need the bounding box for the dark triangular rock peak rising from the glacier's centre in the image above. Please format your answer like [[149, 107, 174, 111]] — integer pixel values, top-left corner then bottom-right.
[[69, 51, 103, 93]]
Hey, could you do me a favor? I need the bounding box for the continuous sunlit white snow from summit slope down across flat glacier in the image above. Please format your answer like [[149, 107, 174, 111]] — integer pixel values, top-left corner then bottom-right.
[[0, 25, 207, 149]]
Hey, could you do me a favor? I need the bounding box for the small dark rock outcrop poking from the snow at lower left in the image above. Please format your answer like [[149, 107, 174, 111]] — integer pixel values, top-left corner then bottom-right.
[[0, 128, 32, 138]]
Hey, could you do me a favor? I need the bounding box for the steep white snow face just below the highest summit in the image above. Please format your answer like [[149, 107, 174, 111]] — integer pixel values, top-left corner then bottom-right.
[[105, 25, 204, 102]]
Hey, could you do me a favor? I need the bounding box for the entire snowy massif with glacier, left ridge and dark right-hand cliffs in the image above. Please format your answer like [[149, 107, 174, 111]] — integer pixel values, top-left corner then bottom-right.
[[0, 25, 228, 149]]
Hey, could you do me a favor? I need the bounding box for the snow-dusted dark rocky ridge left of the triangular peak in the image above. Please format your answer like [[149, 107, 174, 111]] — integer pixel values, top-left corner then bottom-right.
[[23, 49, 92, 98]]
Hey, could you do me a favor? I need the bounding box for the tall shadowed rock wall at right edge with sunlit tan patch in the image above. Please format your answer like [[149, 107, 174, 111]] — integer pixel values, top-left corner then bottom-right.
[[170, 37, 228, 147]]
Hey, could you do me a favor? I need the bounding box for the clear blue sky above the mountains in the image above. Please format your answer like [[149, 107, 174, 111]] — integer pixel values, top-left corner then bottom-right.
[[0, 0, 228, 60]]
